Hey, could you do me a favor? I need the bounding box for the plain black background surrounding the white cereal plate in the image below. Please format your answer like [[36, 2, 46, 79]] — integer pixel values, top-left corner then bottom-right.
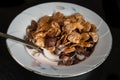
[[0, 0, 120, 80]]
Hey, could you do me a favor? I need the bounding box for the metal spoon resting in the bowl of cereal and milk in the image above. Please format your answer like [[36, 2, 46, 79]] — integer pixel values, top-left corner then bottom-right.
[[0, 32, 60, 62]]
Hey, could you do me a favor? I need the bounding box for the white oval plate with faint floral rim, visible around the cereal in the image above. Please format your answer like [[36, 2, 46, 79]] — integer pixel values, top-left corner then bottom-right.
[[6, 2, 112, 77]]
